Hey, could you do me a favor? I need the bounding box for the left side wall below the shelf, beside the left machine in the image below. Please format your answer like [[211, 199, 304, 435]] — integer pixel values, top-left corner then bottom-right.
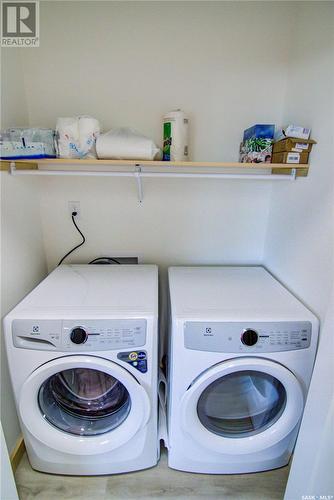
[[1, 176, 47, 452]]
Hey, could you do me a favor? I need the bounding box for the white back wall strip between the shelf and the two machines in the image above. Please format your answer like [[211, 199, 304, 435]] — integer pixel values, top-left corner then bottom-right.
[[37, 178, 268, 269]]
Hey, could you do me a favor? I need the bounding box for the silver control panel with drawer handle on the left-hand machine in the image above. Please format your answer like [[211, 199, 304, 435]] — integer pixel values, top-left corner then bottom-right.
[[12, 319, 147, 352]]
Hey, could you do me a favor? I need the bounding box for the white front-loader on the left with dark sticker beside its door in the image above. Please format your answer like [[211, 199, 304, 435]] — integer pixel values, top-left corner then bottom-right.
[[4, 265, 159, 475]]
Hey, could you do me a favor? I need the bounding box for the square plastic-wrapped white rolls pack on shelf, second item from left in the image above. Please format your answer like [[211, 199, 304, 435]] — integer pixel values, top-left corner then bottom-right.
[[56, 116, 100, 158]]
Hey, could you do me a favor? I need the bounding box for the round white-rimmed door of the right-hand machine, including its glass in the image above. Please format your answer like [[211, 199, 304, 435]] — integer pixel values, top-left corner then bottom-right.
[[181, 358, 304, 455]]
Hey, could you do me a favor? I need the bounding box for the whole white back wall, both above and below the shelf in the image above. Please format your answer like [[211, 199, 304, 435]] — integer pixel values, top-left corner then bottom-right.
[[20, 2, 295, 269]]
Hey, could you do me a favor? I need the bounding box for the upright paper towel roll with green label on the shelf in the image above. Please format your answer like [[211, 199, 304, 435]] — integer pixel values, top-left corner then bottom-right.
[[163, 109, 189, 161]]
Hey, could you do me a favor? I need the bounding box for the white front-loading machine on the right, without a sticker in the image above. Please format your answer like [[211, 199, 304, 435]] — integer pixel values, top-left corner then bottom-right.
[[167, 267, 318, 474]]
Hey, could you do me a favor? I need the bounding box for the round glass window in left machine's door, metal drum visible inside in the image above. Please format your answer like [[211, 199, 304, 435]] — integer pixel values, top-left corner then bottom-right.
[[38, 368, 131, 436]]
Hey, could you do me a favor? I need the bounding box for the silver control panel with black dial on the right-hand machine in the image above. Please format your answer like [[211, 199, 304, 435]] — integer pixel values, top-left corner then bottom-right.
[[184, 321, 312, 353]]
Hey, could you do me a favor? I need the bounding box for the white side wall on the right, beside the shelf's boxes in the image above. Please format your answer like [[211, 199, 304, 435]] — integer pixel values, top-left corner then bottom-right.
[[265, 2, 334, 319]]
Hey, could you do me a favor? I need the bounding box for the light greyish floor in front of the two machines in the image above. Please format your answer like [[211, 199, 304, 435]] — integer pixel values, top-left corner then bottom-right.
[[16, 452, 289, 500]]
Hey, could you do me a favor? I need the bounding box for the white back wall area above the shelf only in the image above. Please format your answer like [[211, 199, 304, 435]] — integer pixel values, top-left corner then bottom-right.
[[24, 1, 295, 161]]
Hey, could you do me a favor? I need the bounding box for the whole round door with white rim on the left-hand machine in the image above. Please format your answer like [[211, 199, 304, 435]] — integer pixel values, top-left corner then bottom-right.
[[19, 356, 150, 455]]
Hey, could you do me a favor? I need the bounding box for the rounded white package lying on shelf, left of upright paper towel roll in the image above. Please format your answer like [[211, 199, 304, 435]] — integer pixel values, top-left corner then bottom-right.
[[96, 128, 161, 160]]
